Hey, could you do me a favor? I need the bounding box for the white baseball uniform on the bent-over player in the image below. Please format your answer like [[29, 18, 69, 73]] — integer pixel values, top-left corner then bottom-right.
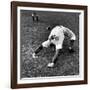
[[42, 25, 76, 50]]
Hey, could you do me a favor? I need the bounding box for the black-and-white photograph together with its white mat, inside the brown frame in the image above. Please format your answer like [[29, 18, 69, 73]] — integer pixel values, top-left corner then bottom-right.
[[10, 1, 85, 88]]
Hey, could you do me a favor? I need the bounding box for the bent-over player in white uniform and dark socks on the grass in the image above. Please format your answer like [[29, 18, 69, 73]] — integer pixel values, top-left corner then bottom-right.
[[32, 25, 76, 67]]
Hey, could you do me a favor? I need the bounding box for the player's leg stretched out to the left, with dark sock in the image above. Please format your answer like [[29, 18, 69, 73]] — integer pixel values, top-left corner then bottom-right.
[[32, 40, 51, 58]]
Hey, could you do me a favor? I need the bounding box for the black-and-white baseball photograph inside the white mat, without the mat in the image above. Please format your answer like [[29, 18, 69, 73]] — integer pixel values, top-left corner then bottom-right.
[[20, 10, 80, 78]]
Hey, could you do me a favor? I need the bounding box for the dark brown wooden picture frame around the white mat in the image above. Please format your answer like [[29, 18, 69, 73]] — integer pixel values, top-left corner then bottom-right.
[[11, 1, 87, 89]]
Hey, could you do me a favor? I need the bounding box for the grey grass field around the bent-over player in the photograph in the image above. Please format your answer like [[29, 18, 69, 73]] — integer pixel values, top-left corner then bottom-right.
[[20, 10, 79, 78]]
